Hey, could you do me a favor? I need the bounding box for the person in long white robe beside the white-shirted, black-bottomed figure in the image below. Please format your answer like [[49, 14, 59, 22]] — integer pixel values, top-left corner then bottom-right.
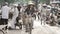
[[11, 4, 19, 29]]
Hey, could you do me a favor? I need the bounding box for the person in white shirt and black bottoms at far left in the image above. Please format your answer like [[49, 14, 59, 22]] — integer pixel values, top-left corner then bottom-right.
[[1, 2, 10, 29]]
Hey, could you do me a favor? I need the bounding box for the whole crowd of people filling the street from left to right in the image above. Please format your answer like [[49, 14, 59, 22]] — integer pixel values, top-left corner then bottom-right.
[[0, 1, 60, 32]]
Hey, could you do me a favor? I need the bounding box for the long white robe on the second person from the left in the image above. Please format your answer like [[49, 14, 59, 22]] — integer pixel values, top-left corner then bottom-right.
[[9, 8, 19, 29]]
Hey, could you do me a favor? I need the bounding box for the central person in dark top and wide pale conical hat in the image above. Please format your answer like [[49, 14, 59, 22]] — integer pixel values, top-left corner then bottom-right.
[[25, 1, 36, 29]]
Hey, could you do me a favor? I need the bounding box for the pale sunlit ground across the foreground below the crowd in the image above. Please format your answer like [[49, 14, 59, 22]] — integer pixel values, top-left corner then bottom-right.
[[0, 17, 60, 34]]
